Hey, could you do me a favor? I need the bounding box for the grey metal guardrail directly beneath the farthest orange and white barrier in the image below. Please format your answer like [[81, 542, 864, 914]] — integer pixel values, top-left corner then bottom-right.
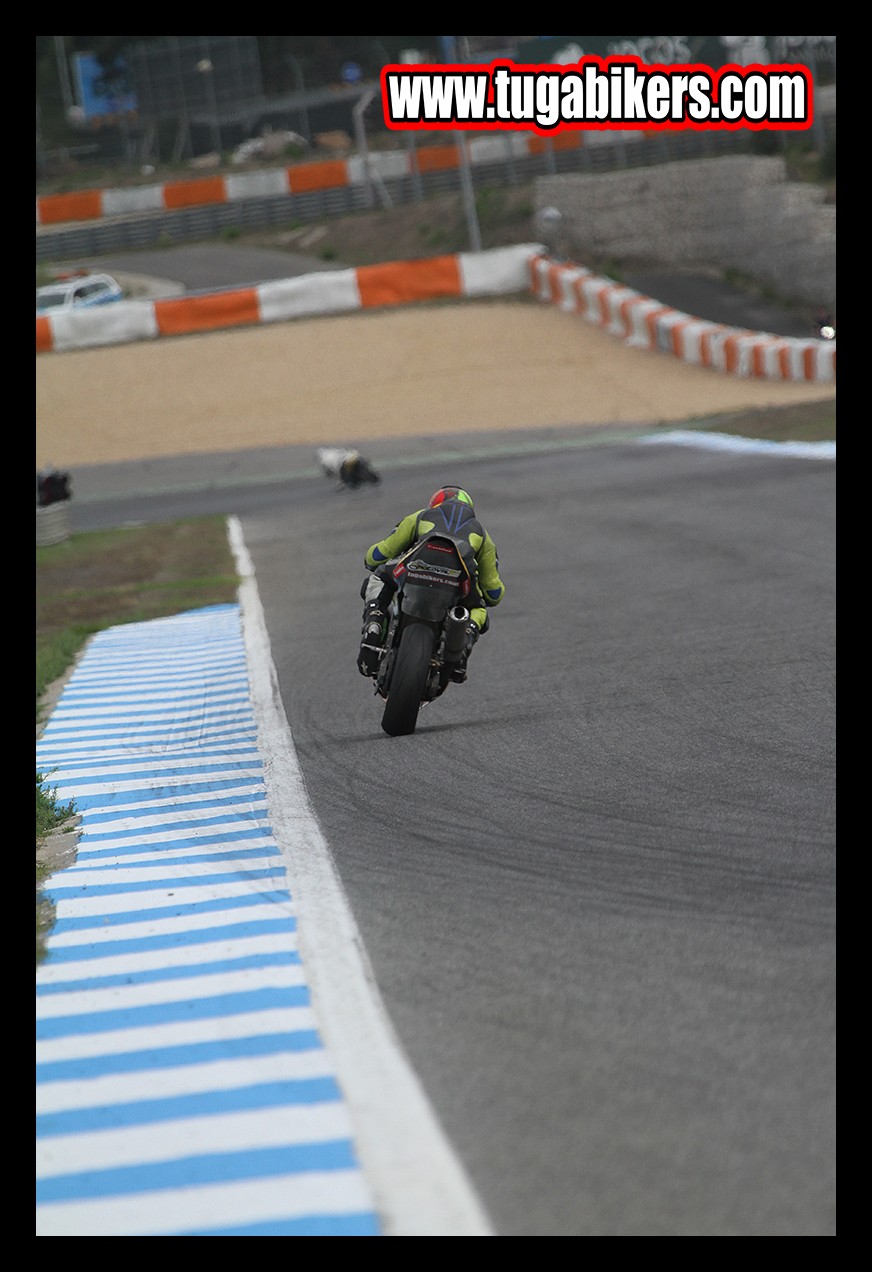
[[37, 122, 835, 263]]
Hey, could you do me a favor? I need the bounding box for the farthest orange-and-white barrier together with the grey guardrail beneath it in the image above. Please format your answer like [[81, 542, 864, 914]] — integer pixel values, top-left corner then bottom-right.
[[36, 122, 818, 263]]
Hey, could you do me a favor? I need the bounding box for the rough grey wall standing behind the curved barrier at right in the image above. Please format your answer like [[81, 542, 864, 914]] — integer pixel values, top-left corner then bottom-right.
[[535, 155, 836, 313]]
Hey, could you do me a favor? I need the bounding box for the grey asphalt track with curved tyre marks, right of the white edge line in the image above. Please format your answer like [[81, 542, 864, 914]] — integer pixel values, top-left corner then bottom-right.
[[243, 444, 835, 1235]]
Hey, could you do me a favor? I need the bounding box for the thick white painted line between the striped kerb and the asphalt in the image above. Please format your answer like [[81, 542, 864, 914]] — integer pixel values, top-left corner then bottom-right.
[[228, 516, 496, 1236]]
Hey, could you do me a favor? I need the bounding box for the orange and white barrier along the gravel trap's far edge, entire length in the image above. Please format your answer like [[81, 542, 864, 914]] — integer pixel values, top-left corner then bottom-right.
[[37, 243, 836, 384]]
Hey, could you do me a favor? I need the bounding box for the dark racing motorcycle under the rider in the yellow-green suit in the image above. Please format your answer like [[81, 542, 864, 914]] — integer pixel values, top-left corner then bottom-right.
[[370, 534, 475, 738]]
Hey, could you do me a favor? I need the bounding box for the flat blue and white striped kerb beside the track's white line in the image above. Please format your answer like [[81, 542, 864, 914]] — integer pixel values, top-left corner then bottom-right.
[[37, 604, 380, 1236]]
